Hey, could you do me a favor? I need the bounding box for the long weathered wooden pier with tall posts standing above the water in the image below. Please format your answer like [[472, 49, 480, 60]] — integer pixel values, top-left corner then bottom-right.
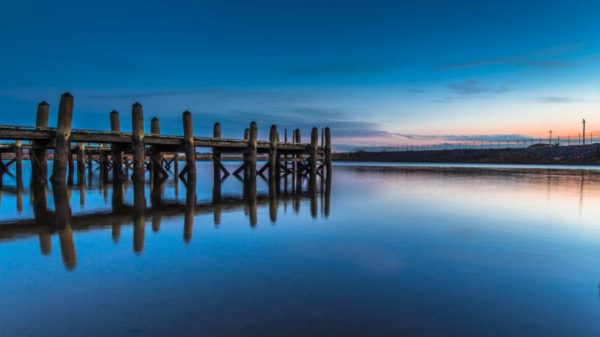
[[0, 93, 331, 192]]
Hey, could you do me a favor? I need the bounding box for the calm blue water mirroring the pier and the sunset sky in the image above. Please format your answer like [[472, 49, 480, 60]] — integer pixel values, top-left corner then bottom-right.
[[0, 163, 600, 337]]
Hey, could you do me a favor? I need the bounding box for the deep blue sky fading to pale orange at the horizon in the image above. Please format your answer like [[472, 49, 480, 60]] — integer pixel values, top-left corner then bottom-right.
[[0, 0, 600, 148]]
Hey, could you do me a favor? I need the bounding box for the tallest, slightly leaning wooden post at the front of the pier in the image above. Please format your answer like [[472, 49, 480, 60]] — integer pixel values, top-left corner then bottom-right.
[[50, 93, 73, 184]]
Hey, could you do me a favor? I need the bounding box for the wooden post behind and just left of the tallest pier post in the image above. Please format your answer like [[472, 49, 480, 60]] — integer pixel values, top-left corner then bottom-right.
[[29, 102, 50, 185]]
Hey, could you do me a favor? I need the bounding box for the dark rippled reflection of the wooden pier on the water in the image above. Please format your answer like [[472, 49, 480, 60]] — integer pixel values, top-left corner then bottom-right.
[[0, 162, 331, 269]]
